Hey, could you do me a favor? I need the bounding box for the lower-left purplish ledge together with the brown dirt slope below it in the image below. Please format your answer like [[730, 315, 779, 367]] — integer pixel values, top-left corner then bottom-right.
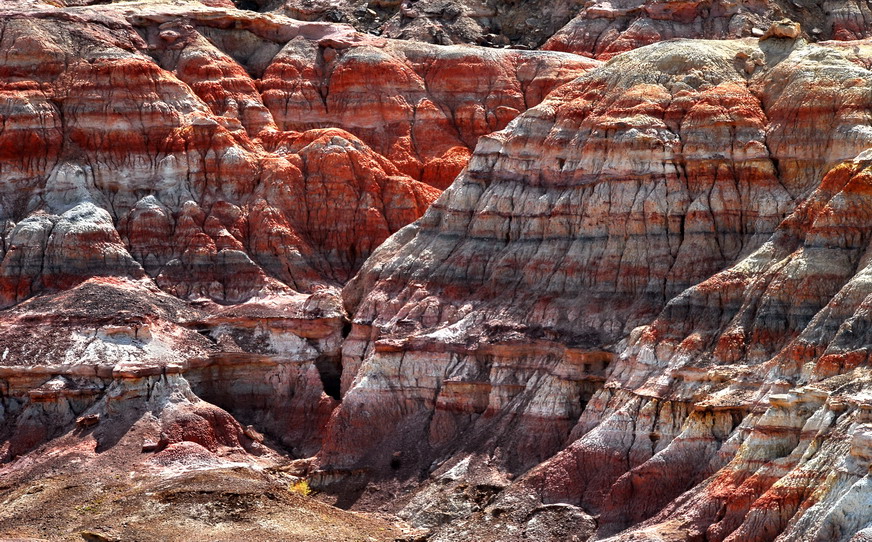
[[0, 277, 401, 541]]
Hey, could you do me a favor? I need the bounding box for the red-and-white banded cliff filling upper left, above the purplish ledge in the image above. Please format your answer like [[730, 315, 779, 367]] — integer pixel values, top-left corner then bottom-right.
[[0, 3, 595, 306]]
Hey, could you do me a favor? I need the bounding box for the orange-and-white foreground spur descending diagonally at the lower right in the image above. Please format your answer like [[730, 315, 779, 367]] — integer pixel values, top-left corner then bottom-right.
[[572, 146, 870, 540]]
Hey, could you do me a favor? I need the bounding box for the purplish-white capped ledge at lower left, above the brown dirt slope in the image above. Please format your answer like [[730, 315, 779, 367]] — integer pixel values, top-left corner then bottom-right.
[[0, 278, 343, 461]]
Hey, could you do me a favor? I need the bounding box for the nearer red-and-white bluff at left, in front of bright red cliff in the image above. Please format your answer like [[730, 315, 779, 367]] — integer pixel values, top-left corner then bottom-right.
[[0, 6, 426, 306]]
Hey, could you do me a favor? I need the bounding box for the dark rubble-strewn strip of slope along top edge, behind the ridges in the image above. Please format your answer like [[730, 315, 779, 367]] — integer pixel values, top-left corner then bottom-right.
[[237, 0, 872, 59]]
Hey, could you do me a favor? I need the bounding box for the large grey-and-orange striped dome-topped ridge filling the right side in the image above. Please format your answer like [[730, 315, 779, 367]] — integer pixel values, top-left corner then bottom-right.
[[320, 36, 872, 540]]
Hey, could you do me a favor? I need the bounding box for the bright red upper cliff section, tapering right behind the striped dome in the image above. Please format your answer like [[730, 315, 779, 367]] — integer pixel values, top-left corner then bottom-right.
[[261, 36, 595, 188]]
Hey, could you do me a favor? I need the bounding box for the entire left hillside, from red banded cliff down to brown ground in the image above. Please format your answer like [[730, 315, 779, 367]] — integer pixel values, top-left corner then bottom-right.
[[0, 1, 598, 540]]
